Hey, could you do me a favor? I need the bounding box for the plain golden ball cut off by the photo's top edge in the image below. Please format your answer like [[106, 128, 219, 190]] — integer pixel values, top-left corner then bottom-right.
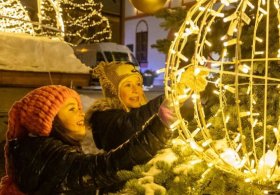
[[129, 0, 167, 14]]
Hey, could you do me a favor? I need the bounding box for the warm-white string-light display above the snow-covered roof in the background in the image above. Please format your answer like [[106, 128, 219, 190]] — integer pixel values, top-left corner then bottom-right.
[[0, 0, 112, 45]]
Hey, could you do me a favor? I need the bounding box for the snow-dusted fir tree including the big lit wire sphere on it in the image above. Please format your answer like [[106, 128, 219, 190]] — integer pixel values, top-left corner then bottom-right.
[[114, 0, 280, 194]]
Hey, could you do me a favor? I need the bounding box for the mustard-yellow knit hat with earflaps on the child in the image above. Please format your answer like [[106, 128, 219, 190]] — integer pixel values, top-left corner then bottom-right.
[[93, 62, 149, 107]]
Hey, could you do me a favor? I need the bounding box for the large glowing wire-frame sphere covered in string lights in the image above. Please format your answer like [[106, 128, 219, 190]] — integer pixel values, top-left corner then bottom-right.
[[165, 0, 280, 188]]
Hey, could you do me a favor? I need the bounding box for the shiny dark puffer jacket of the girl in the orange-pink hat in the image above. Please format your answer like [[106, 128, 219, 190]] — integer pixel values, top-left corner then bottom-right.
[[8, 117, 171, 195]]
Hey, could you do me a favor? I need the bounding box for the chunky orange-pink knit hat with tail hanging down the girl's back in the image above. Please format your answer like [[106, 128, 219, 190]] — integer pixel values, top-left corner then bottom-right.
[[0, 85, 82, 195]]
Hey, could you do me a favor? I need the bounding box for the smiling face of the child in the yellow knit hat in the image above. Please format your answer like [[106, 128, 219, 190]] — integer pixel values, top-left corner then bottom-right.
[[119, 76, 144, 108]]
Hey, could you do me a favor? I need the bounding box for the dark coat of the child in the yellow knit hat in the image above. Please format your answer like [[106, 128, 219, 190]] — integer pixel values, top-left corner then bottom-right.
[[87, 95, 163, 151]]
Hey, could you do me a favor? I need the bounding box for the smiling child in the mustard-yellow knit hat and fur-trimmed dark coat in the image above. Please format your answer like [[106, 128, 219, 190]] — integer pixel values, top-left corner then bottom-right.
[[86, 62, 164, 151]]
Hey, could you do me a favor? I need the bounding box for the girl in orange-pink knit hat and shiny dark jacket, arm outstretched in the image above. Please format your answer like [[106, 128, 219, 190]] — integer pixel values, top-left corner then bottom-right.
[[0, 85, 174, 195]]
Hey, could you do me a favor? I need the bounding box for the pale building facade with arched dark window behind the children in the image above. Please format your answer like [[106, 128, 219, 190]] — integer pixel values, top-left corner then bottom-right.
[[123, 0, 195, 85]]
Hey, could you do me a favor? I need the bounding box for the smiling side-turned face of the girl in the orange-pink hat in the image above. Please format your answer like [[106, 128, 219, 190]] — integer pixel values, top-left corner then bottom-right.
[[57, 98, 86, 140]]
